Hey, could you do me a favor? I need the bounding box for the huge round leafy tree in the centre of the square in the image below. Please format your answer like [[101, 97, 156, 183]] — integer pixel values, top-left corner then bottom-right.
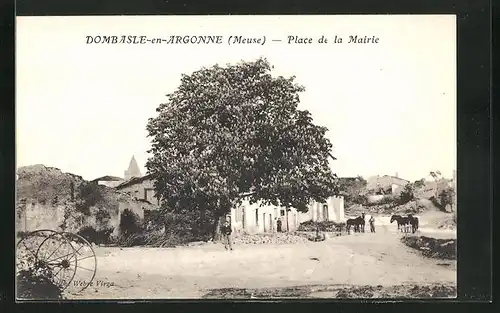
[[146, 59, 337, 235]]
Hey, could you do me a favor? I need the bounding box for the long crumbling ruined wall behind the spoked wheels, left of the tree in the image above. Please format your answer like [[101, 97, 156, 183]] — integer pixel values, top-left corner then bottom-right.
[[16, 165, 156, 234]]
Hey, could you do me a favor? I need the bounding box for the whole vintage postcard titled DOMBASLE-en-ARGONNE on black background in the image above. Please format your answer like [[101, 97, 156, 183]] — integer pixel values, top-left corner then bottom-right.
[[16, 15, 459, 300]]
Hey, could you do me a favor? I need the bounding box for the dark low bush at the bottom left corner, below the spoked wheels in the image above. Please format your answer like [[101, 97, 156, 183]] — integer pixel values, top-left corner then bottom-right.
[[16, 269, 63, 300]]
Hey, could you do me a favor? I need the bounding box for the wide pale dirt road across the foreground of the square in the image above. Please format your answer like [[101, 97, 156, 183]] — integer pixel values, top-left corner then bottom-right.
[[68, 229, 456, 299]]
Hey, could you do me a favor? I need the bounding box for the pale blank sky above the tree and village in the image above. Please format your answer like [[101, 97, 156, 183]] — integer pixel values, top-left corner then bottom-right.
[[16, 15, 456, 180]]
